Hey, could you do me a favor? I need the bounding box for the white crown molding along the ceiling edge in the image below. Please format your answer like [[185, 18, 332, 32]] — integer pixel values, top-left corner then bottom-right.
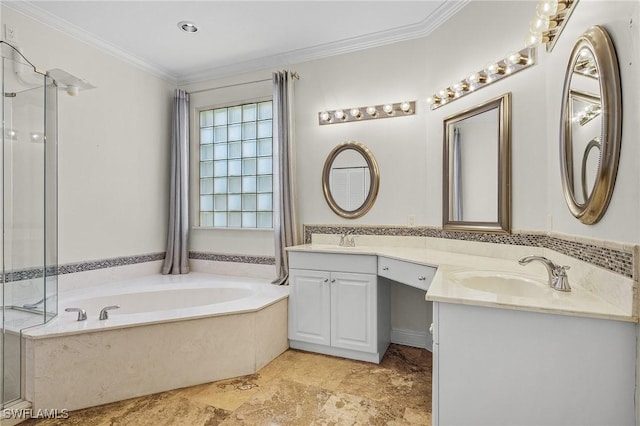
[[2, 0, 471, 85]]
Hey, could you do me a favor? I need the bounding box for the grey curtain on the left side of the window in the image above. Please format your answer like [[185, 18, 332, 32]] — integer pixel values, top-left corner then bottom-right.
[[162, 89, 189, 275]]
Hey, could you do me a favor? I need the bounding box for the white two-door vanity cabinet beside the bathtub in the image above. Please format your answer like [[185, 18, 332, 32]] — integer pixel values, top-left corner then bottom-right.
[[289, 252, 389, 363]]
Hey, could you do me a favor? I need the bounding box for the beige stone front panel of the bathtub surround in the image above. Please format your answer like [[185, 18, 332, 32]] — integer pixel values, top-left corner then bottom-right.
[[25, 299, 289, 410]]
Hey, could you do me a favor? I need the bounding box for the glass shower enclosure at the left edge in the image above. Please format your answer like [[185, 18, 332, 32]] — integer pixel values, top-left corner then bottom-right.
[[0, 41, 58, 408]]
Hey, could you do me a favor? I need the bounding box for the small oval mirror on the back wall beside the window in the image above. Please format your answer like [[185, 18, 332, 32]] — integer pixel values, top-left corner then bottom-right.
[[322, 141, 380, 219]]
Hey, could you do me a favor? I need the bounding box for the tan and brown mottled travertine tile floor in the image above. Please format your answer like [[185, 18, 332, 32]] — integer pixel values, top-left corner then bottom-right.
[[23, 345, 432, 426]]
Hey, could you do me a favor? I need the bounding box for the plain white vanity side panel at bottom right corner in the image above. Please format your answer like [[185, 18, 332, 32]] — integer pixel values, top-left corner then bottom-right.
[[432, 302, 636, 426]]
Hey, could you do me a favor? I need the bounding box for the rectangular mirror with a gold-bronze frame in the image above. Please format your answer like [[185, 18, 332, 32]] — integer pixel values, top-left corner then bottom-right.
[[442, 93, 511, 233]]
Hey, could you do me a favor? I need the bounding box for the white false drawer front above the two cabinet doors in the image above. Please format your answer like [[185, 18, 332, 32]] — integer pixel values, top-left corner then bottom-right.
[[289, 251, 378, 274]]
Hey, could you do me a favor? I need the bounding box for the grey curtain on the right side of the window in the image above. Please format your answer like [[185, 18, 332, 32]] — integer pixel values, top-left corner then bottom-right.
[[273, 71, 298, 285]]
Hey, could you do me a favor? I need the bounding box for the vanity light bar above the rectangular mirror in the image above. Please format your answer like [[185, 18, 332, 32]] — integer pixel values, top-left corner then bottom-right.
[[427, 47, 536, 110]]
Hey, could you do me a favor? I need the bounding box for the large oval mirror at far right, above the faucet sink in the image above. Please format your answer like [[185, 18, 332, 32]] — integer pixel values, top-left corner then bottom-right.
[[560, 26, 622, 224]]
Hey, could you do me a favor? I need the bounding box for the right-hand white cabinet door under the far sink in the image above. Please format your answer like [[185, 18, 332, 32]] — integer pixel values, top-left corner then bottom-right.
[[331, 272, 378, 352]]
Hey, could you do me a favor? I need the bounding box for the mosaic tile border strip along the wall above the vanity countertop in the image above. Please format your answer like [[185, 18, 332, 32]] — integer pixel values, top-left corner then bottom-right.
[[304, 225, 637, 278]]
